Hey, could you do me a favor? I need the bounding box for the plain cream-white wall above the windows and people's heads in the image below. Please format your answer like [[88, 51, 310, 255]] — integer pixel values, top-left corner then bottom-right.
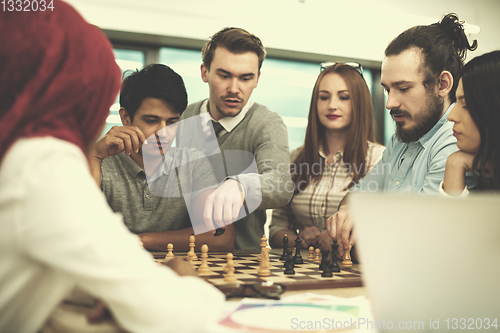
[[67, 0, 500, 61]]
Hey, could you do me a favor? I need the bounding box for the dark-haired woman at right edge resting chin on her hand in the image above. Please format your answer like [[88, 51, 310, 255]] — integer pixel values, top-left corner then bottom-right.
[[441, 50, 500, 196]]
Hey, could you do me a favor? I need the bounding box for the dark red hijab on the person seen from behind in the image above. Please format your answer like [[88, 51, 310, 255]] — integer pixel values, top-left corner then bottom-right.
[[0, 0, 120, 161]]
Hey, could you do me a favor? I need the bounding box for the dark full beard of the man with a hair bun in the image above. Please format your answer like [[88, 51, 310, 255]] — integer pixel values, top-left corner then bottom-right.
[[391, 94, 444, 143]]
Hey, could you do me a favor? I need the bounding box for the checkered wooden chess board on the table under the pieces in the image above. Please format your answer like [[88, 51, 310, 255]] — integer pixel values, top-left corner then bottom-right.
[[154, 251, 362, 290]]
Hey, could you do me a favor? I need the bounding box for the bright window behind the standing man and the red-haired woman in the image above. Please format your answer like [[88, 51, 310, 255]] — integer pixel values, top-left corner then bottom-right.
[[160, 47, 372, 150]]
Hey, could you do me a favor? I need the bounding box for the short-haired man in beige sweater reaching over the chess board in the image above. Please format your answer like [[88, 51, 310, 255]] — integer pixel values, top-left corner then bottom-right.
[[177, 28, 292, 249]]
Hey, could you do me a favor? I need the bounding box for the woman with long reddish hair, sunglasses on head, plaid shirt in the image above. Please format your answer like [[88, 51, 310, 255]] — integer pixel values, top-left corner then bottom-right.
[[270, 63, 384, 248]]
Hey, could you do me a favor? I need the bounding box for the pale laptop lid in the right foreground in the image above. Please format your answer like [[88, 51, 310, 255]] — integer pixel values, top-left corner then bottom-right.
[[350, 193, 500, 332]]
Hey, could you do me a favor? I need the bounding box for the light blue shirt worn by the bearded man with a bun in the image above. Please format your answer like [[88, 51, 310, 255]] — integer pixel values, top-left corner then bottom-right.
[[352, 103, 458, 194]]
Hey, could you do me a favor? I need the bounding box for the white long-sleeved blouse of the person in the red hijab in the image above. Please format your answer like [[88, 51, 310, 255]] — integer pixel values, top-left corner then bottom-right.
[[0, 137, 224, 333]]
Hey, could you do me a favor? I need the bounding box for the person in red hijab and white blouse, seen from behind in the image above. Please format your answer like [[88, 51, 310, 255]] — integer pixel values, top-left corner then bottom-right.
[[0, 0, 224, 333]]
